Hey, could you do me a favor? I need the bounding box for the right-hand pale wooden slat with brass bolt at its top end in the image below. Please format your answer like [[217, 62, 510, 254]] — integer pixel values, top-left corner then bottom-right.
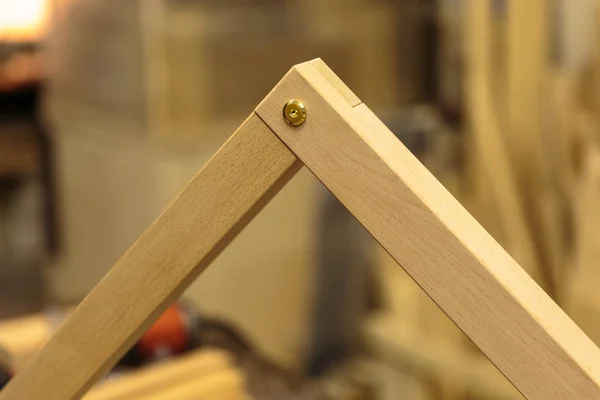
[[256, 59, 600, 400]]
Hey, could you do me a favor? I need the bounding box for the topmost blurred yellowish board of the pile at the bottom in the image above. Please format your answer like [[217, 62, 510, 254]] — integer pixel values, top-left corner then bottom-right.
[[83, 350, 233, 400]]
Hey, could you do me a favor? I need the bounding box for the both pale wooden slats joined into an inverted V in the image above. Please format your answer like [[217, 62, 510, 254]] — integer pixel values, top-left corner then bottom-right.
[[0, 61, 600, 400]]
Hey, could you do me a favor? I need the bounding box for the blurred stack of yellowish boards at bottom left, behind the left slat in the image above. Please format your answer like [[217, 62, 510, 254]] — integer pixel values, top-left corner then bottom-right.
[[0, 315, 246, 400]]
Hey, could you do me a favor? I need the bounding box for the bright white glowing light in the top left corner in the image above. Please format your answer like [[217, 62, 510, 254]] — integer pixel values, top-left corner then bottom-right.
[[0, 0, 50, 41]]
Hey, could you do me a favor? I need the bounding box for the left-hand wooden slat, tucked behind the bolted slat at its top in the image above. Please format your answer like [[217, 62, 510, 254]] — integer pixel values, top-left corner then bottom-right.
[[0, 115, 301, 400]]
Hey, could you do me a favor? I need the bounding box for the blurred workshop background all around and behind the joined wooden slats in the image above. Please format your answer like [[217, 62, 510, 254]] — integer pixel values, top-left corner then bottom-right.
[[0, 0, 600, 400]]
